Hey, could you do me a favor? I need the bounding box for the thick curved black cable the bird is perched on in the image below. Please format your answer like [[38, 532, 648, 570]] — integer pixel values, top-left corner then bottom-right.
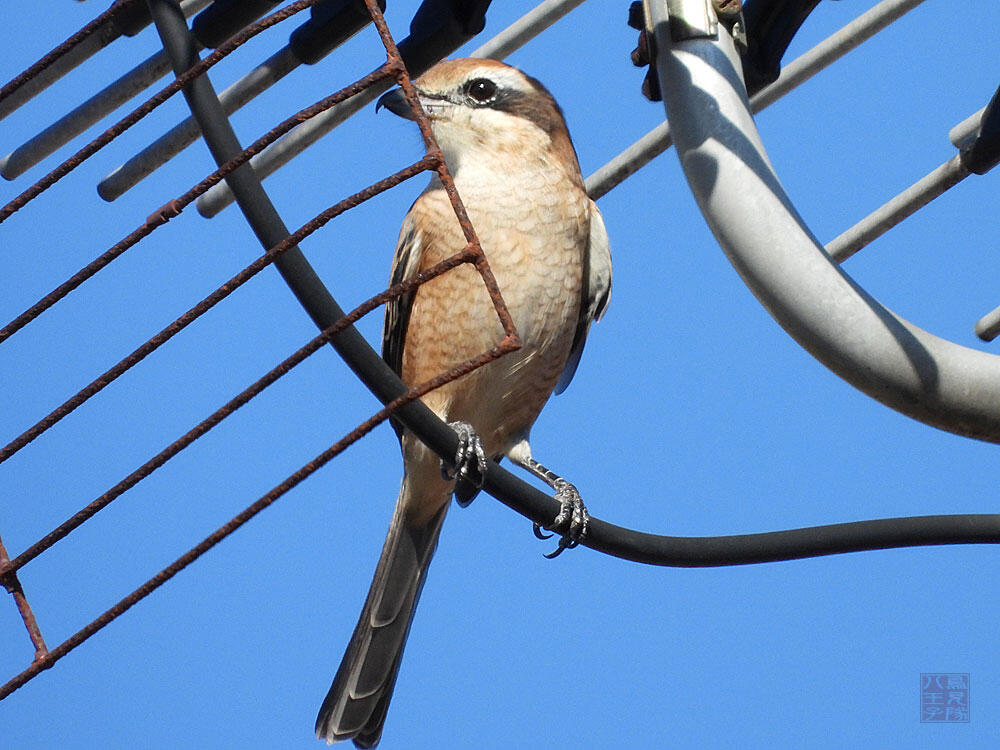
[[148, 0, 1000, 567]]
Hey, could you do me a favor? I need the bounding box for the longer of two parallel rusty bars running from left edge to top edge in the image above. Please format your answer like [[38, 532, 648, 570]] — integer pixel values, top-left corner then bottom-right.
[[0, 0, 320, 229]]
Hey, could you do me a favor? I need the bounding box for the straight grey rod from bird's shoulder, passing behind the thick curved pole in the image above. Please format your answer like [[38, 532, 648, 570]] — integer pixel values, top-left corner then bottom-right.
[[587, 0, 924, 200]]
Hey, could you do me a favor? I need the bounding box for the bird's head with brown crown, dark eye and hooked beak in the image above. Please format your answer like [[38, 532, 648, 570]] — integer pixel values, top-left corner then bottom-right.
[[378, 58, 580, 181]]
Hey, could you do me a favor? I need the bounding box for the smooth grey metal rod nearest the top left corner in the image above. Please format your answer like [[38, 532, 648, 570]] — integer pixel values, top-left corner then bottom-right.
[[0, 0, 212, 122]]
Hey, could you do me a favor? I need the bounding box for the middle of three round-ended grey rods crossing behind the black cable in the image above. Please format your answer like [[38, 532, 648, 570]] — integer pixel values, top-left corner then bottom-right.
[[97, 46, 301, 201]]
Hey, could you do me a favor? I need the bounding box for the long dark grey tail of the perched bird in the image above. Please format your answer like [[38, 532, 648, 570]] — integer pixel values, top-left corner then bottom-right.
[[316, 479, 450, 747]]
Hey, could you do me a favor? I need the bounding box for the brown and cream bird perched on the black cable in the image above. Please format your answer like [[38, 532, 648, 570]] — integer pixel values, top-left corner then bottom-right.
[[316, 58, 611, 748]]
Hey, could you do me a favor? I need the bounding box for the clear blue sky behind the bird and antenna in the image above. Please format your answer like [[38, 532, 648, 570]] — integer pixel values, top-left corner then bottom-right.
[[0, 0, 1000, 748]]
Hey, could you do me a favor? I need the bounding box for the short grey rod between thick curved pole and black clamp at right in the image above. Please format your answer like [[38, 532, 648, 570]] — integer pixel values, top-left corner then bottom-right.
[[826, 154, 971, 263]]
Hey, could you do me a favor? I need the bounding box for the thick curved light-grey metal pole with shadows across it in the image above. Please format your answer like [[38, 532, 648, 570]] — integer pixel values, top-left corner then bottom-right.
[[647, 0, 1000, 442]]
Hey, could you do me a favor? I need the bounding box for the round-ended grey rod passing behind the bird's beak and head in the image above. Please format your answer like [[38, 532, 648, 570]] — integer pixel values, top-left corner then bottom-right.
[[197, 0, 582, 219]]
